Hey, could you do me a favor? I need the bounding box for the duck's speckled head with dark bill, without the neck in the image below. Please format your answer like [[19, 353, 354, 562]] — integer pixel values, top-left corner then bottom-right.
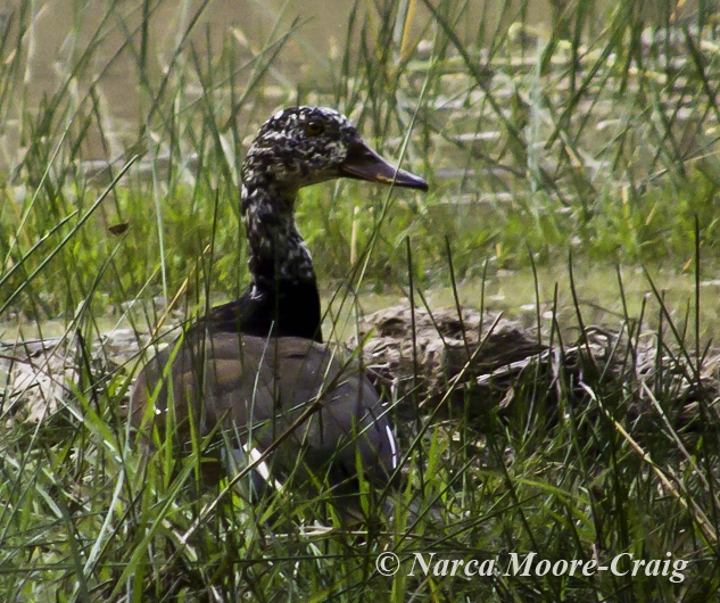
[[243, 107, 428, 191]]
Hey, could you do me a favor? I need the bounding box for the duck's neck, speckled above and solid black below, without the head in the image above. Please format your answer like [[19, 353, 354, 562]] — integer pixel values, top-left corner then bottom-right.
[[241, 175, 322, 341]]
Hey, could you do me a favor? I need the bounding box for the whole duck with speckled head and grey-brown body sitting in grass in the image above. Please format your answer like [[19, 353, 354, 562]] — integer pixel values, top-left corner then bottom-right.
[[129, 106, 428, 509]]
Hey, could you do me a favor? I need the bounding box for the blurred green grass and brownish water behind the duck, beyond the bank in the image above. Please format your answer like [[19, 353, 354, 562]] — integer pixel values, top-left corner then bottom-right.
[[0, 0, 720, 330]]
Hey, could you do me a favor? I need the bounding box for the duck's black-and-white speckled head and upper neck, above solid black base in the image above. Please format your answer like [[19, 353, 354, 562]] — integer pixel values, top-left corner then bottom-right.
[[241, 107, 427, 294]]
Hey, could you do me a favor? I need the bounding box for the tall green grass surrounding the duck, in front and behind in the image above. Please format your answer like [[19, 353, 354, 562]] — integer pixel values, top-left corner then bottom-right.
[[0, 0, 720, 602]]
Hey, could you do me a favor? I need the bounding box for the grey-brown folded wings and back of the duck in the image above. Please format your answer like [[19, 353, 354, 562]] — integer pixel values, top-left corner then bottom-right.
[[131, 333, 399, 494]]
